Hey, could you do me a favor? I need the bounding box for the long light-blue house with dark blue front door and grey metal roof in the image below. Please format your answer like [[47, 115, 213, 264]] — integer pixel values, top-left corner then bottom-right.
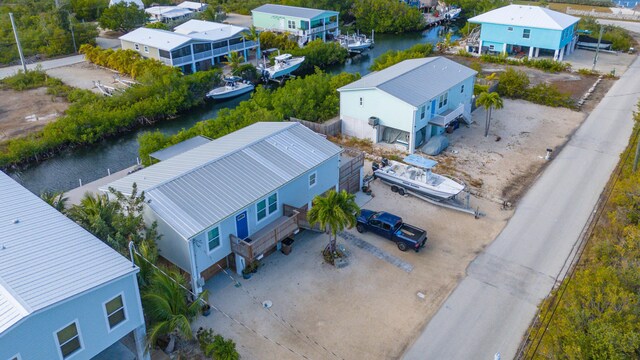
[[100, 122, 342, 292]]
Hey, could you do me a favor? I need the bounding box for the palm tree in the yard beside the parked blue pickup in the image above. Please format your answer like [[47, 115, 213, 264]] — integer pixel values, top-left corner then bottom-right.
[[307, 190, 360, 254]]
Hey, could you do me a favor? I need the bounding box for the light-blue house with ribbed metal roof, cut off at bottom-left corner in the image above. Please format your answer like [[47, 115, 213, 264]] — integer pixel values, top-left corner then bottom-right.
[[0, 172, 149, 360]]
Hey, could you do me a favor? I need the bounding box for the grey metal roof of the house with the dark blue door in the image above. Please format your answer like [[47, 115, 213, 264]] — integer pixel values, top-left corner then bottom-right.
[[107, 122, 341, 239]]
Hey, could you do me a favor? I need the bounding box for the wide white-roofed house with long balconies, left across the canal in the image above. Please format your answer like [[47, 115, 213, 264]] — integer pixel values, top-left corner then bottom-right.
[[120, 19, 260, 74]]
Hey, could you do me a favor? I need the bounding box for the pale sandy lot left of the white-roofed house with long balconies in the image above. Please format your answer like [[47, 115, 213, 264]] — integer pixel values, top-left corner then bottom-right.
[[47, 61, 130, 93]]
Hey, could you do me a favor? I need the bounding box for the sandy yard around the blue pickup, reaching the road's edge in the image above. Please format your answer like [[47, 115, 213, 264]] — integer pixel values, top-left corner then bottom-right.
[[193, 187, 511, 360]]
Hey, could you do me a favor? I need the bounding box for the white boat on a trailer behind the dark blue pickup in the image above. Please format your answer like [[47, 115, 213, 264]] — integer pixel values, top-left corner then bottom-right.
[[373, 154, 465, 200]]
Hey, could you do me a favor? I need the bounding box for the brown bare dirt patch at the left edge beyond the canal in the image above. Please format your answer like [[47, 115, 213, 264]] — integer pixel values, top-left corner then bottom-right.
[[0, 88, 69, 141]]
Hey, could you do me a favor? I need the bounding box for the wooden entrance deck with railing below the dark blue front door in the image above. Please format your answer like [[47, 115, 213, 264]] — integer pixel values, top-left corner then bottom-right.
[[229, 212, 298, 261]]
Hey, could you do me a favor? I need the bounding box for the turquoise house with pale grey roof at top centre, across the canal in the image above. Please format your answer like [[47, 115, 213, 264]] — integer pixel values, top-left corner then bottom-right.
[[251, 4, 340, 43]]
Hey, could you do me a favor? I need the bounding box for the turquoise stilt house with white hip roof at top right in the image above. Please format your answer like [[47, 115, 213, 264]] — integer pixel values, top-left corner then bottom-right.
[[468, 5, 580, 61]]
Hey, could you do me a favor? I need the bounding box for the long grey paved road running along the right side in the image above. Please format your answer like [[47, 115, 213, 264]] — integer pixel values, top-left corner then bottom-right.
[[404, 55, 640, 360]]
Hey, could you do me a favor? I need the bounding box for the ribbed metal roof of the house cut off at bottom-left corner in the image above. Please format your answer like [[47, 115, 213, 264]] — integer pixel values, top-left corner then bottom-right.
[[0, 172, 138, 334]]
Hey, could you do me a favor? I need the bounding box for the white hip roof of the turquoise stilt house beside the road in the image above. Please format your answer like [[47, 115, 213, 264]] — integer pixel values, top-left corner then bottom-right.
[[468, 5, 580, 30]]
